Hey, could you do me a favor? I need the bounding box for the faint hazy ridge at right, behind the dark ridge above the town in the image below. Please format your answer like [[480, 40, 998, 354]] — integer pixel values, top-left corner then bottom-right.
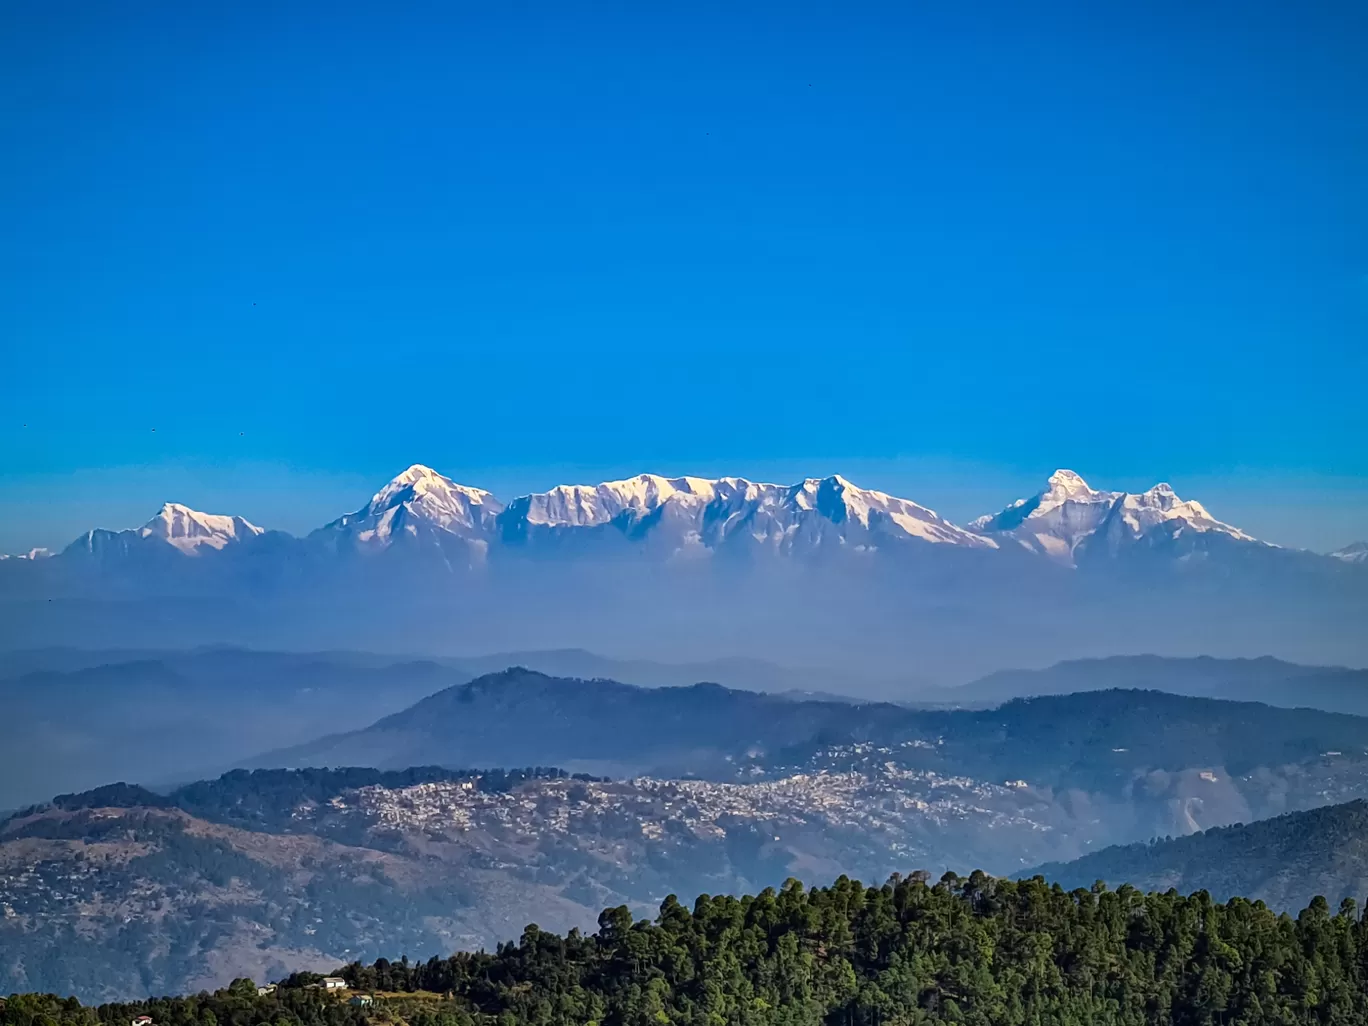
[[941, 655, 1368, 715]]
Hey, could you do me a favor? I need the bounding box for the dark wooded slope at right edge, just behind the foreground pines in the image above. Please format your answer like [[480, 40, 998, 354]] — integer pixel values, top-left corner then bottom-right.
[[1023, 799, 1368, 910]]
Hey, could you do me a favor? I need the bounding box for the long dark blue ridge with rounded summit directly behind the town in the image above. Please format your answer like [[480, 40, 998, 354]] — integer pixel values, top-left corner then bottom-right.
[[258, 669, 1368, 836]]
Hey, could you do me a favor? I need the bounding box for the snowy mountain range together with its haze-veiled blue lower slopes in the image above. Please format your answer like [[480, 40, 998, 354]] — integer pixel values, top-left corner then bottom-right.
[[0, 465, 1368, 683]]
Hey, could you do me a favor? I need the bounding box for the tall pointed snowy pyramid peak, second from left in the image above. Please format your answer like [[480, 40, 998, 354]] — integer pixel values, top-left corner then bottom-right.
[[315, 464, 503, 549]]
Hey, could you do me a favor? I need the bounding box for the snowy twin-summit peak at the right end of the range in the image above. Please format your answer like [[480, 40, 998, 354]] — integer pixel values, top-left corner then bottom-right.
[[970, 469, 1256, 565]]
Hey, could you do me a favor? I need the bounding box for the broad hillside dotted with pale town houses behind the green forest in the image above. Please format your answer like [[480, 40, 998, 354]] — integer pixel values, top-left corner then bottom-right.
[[13, 738, 1368, 997]]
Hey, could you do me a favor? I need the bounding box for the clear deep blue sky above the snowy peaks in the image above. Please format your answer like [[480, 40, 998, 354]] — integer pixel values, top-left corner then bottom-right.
[[0, 1, 1368, 550]]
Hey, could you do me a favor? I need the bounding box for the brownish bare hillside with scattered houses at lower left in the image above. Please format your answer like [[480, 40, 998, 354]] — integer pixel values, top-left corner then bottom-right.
[[0, 807, 569, 997]]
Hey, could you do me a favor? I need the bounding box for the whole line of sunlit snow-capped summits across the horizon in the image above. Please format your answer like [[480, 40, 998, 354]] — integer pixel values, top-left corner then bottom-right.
[[2, 464, 1302, 562]]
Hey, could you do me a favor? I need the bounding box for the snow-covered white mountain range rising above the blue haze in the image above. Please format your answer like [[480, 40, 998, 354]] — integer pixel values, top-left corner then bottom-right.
[[13, 464, 1346, 566]]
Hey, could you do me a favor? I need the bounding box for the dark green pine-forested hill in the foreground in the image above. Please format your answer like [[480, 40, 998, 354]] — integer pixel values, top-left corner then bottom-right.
[[8, 873, 1368, 1026]]
